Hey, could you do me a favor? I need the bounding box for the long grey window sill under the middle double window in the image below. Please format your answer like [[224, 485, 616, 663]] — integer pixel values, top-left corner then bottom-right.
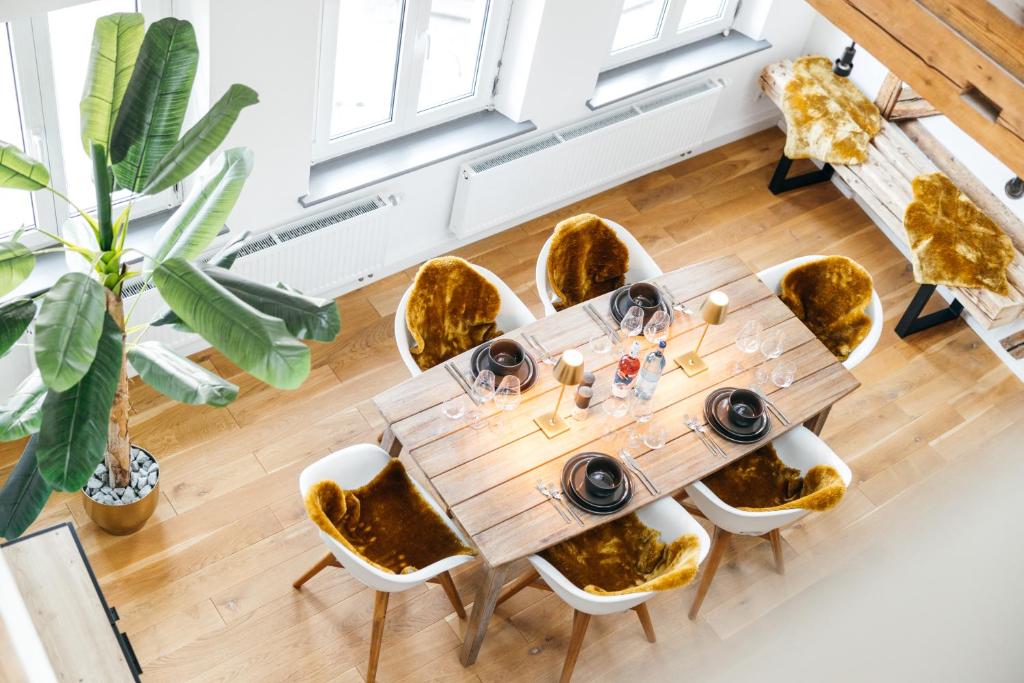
[[299, 112, 537, 208]]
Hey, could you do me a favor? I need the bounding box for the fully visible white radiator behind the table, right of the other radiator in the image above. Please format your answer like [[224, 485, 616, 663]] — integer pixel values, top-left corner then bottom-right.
[[451, 80, 724, 237]]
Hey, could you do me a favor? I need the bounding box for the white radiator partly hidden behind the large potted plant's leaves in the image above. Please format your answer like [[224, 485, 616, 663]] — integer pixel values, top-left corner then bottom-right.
[[122, 195, 393, 348]]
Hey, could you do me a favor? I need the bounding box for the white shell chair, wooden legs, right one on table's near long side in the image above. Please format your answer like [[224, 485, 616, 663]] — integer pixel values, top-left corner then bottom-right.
[[686, 426, 853, 618]]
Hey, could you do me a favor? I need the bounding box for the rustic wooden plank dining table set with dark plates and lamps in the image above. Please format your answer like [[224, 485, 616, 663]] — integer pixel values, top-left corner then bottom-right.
[[374, 256, 859, 666]]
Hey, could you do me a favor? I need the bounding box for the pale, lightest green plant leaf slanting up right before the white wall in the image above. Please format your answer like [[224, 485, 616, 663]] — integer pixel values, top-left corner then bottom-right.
[[145, 147, 253, 271]]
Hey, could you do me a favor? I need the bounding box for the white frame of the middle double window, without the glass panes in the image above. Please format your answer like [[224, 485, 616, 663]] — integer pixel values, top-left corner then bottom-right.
[[312, 0, 511, 164]]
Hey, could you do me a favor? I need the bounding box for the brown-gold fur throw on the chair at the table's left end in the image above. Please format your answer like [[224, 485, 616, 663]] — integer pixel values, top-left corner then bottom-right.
[[306, 459, 475, 573]]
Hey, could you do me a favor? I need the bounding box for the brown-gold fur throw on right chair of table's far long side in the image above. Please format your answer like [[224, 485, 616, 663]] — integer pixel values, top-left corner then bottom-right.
[[547, 213, 630, 310]]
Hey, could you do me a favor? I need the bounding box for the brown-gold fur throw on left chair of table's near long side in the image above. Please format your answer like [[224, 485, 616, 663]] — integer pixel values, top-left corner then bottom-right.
[[541, 514, 700, 595]]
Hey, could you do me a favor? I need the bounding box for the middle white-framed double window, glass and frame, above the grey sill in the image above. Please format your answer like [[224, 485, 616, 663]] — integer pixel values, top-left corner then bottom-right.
[[313, 0, 508, 161]]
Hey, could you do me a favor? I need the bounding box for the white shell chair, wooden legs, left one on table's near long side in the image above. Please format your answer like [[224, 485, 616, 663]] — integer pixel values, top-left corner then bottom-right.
[[497, 498, 710, 683]]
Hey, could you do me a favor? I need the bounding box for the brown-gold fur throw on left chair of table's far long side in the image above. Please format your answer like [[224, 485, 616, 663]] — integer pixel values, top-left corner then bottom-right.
[[406, 256, 502, 370]]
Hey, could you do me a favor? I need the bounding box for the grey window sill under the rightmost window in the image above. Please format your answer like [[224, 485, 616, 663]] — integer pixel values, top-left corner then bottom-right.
[[587, 31, 771, 111]]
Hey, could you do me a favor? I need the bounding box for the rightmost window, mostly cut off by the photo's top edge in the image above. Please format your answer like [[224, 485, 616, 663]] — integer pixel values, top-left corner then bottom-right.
[[605, 0, 738, 68]]
